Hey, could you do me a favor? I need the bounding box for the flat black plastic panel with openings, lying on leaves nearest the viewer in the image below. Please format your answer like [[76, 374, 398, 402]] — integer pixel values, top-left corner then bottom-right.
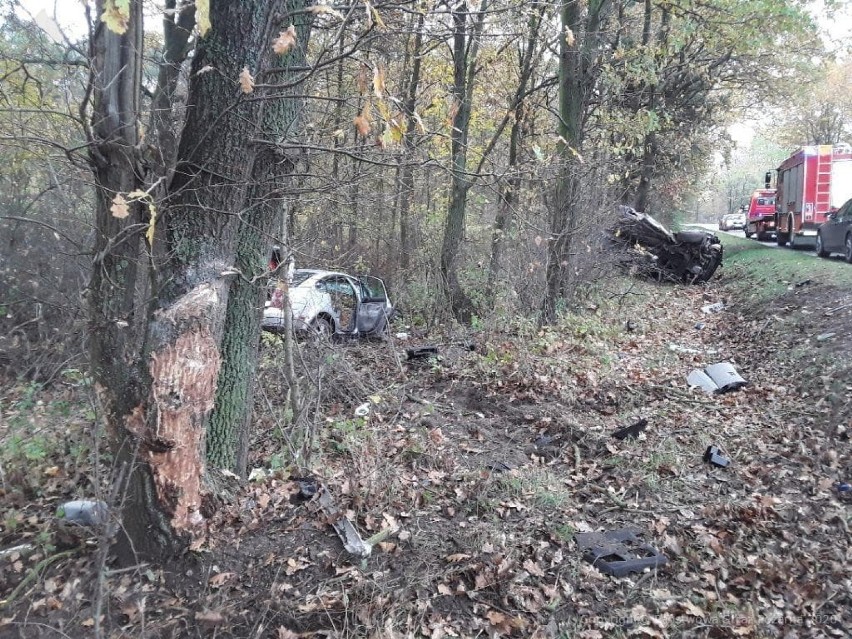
[[574, 528, 668, 577]]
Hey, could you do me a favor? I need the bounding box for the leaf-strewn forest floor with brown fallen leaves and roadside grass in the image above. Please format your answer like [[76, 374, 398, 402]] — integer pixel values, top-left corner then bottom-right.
[[0, 239, 852, 639]]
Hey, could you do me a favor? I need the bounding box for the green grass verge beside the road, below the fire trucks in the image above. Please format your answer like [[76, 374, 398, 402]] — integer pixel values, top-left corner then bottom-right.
[[722, 235, 852, 302]]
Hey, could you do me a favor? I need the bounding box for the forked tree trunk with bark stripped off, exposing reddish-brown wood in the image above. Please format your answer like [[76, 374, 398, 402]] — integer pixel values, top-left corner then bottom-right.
[[92, 0, 308, 561]]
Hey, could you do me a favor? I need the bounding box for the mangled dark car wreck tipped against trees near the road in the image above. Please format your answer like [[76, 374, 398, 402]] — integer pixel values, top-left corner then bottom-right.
[[608, 206, 722, 284]]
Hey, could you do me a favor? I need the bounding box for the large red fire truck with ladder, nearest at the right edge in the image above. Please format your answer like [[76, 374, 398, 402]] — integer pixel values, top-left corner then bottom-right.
[[775, 144, 852, 248]]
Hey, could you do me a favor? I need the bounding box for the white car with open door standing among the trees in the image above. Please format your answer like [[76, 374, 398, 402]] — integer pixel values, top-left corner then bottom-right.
[[261, 269, 395, 337]]
